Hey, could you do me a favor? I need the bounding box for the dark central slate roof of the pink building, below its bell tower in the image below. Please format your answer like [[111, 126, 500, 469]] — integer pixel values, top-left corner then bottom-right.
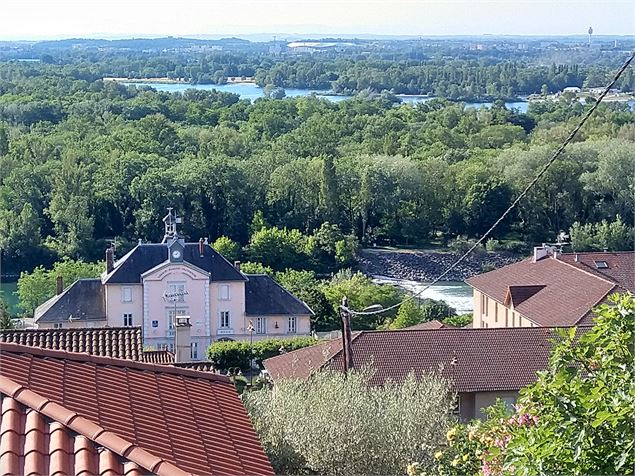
[[103, 243, 247, 284]]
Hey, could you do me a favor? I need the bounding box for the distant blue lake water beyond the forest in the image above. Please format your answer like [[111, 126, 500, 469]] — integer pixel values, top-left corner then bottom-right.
[[121, 82, 529, 112]]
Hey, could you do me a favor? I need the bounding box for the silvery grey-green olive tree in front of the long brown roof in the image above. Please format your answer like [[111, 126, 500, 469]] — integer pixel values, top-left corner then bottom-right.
[[244, 369, 454, 475]]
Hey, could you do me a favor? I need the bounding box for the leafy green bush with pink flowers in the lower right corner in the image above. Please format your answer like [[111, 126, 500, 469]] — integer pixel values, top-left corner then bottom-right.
[[408, 294, 635, 476]]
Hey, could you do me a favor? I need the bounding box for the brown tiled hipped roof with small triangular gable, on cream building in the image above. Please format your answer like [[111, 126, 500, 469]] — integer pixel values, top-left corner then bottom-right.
[[466, 256, 618, 327]]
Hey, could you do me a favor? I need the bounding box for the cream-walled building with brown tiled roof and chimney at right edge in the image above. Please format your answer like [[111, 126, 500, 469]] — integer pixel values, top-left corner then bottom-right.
[[466, 246, 635, 328]]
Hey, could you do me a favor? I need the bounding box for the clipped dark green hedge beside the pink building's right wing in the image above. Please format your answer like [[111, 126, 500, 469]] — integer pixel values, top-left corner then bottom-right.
[[207, 337, 319, 370]]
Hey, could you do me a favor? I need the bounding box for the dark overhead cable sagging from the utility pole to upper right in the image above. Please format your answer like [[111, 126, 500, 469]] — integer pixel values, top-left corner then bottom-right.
[[348, 51, 635, 316]]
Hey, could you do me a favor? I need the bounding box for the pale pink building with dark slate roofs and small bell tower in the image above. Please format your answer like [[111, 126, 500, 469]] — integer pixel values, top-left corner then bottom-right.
[[34, 210, 313, 360]]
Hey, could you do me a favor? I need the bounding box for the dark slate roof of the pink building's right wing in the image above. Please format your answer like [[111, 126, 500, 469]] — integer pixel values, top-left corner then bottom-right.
[[245, 274, 313, 316]]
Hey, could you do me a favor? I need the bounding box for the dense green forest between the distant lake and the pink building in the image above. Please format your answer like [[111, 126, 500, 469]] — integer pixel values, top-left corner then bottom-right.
[[0, 59, 635, 278]]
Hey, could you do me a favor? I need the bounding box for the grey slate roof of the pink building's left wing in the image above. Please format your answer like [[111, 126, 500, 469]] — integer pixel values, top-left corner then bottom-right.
[[33, 278, 106, 322]]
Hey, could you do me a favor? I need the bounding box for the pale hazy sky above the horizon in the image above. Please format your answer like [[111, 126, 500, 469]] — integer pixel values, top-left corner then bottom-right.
[[0, 0, 635, 39]]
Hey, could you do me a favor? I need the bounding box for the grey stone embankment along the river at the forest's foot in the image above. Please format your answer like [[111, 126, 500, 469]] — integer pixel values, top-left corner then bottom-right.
[[358, 249, 522, 281]]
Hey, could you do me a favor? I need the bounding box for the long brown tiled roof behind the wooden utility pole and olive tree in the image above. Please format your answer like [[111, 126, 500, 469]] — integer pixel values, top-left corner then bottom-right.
[[264, 327, 580, 393]]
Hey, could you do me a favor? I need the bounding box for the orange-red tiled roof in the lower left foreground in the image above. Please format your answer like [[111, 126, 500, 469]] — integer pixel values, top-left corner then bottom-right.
[[0, 343, 273, 475]]
